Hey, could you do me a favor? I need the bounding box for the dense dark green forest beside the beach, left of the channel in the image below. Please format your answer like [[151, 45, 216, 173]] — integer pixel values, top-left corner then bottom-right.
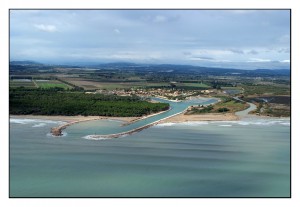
[[9, 88, 169, 117]]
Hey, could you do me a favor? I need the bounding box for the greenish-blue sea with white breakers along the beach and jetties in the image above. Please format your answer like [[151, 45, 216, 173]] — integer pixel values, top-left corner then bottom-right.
[[9, 117, 291, 198]]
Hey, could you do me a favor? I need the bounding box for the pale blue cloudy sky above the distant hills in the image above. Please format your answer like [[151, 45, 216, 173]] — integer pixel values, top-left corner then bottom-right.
[[10, 10, 290, 69]]
